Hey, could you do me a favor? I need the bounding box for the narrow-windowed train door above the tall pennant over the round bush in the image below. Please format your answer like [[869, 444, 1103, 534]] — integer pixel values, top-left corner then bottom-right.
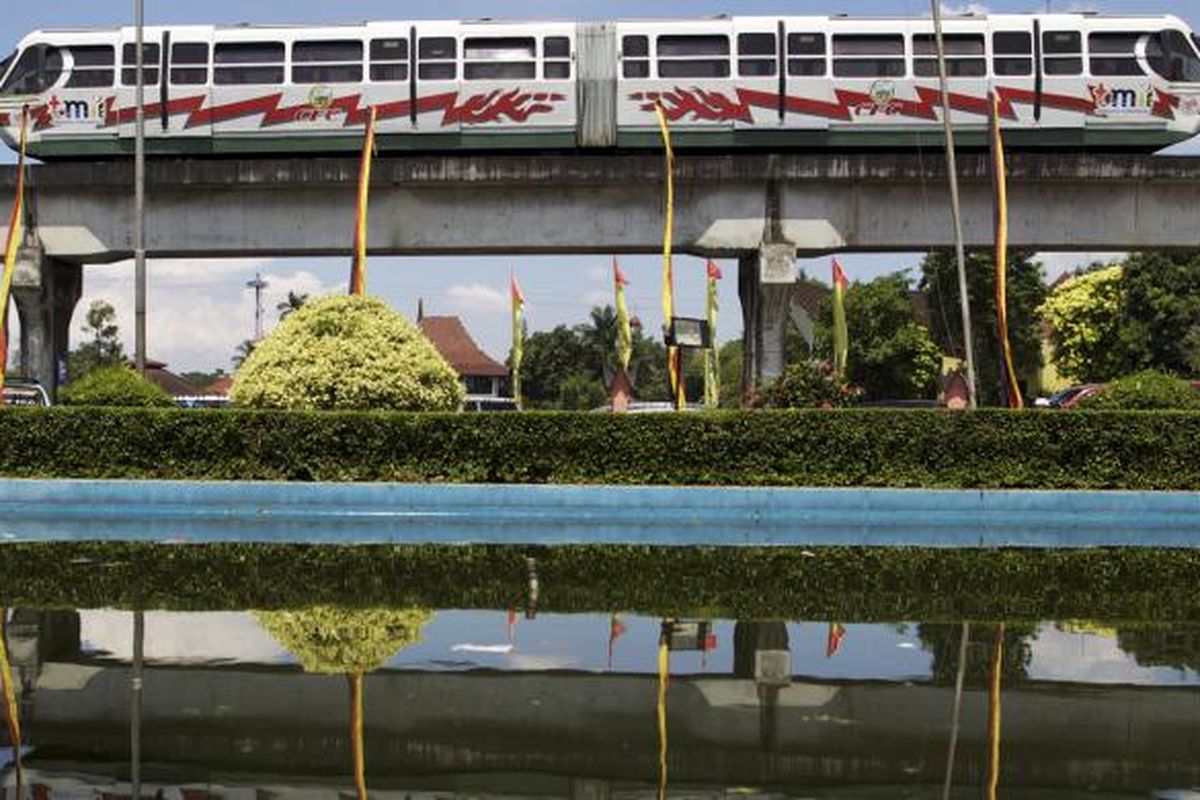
[[361, 23, 416, 139]]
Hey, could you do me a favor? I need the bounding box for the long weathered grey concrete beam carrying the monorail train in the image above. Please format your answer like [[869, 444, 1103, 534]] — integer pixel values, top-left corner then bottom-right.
[[0, 152, 1200, 263]]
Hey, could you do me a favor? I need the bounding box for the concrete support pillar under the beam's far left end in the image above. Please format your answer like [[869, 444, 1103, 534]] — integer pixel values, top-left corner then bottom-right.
[[12, 248, 83, 397]]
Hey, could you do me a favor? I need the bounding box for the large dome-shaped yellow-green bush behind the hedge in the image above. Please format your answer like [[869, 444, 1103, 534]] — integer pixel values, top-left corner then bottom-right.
[[230, 295, 464, 411]]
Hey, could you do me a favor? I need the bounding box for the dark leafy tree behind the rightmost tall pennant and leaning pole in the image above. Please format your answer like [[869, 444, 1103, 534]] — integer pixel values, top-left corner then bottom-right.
[[920, 251, 1046, 405]]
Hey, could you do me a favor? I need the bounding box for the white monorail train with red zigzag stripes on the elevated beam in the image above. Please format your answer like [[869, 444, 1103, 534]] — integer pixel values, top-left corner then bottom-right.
[[0, 13, 1200, 158]]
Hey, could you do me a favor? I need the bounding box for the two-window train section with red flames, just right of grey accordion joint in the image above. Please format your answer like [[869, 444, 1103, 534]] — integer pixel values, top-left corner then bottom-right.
[[617, 19, 746, 144]]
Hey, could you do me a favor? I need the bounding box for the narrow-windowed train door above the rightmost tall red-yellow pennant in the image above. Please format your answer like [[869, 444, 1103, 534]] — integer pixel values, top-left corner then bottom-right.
[[988, 17, 1042, 131]]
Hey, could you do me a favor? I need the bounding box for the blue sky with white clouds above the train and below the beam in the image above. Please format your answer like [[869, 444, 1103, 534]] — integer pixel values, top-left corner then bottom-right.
[[0, 0, 1200, 371]]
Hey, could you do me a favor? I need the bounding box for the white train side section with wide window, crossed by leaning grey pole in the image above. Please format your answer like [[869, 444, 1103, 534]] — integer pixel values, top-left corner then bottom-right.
[[905, 19, 991, 137]]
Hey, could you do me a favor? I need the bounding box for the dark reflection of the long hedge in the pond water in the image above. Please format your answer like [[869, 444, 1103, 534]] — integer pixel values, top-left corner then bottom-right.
[[0, 542, 1200, 622]]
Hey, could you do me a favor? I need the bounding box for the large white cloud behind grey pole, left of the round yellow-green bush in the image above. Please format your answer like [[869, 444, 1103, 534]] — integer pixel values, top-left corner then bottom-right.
[[71, 259, 337, 372]]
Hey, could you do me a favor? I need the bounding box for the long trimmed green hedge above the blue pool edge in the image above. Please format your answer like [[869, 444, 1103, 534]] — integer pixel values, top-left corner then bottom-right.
[[0, 408, 1200, 491]]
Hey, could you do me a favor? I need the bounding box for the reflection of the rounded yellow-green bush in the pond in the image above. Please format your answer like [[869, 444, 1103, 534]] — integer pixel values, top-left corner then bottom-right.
[[256, 606, 433, 674]]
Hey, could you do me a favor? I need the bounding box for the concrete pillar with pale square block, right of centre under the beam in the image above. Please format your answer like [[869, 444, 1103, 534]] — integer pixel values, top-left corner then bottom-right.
[[738, 242, 796, 397]]
